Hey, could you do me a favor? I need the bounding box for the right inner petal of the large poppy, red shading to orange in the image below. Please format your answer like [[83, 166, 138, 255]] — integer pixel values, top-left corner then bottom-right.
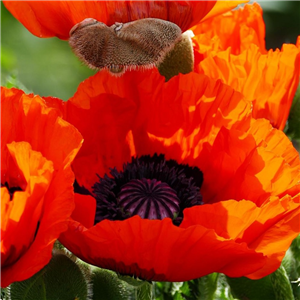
[[195, 124, 299, 206]]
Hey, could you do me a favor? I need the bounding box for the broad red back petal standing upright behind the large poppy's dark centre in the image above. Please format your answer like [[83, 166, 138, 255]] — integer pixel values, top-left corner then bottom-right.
[[46, 69, 251, 189]]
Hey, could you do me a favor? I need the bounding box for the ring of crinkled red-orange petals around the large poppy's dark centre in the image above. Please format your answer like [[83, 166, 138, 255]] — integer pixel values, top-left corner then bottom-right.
[[47, 70, 299, 281]]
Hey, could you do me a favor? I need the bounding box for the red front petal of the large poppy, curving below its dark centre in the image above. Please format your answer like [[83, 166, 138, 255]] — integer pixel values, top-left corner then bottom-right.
[[60, 210, 265, 281]]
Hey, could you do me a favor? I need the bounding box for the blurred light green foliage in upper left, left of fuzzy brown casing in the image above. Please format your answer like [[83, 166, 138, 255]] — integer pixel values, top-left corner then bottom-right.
[[0, 1, 95, 100]]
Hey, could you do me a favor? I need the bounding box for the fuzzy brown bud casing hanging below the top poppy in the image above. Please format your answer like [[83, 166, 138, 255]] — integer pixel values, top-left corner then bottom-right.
[[69, 18, 181, 73]]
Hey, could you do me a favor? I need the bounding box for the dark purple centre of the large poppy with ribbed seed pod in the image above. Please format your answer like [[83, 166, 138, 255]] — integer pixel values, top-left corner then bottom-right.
[[74, 154, 203, 225]]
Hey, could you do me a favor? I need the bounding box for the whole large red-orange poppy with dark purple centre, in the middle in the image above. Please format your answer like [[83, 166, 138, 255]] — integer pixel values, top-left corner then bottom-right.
[[46, 69, 300, 281]]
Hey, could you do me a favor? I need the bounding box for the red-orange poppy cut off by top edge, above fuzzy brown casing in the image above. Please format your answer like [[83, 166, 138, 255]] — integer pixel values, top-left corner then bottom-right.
[[3, 0, 248, 40]]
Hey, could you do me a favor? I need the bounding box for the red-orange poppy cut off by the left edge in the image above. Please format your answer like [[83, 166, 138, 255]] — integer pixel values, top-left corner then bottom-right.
[[0, 88, 82, 287]]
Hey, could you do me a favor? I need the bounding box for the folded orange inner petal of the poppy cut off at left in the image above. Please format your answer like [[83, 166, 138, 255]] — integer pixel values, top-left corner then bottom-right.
[[0, 142, 54, 267]]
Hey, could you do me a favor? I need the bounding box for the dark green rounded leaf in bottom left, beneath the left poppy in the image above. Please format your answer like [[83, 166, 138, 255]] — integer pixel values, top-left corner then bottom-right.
[[10, 253, 88, 300]]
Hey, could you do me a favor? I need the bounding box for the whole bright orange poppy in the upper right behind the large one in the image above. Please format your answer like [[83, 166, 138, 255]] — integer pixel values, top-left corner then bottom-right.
[[193, 3, 300, 130]]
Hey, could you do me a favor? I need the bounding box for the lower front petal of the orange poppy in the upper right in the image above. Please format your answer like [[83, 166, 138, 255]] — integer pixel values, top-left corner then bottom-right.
[[197, 44, 300, 130]]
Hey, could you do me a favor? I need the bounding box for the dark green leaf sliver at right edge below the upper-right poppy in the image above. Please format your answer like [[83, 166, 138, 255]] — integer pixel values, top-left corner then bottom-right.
[[286, 85, 300, 139]]
